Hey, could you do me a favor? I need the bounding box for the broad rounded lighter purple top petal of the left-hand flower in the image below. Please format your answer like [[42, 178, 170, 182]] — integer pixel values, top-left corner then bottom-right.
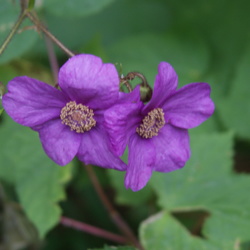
[[58, 54, 119, 109]]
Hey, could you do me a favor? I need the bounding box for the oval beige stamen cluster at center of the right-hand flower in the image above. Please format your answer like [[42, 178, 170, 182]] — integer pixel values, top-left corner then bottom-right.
[[136, 108, 165, 139]]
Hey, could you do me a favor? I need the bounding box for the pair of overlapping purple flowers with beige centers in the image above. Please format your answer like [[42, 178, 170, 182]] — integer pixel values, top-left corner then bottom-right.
[[3, 54, 214, 191]]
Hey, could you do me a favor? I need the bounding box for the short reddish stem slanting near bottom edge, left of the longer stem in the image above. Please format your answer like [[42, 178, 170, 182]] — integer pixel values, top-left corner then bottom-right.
[[60, 216, 127, 244]]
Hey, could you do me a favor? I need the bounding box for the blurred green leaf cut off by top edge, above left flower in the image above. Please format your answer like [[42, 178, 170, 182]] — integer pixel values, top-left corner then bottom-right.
[[44, 0, 114, 18]]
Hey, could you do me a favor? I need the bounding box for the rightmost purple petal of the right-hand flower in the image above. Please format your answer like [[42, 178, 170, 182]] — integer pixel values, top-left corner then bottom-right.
[[163, 83, 214, 129]]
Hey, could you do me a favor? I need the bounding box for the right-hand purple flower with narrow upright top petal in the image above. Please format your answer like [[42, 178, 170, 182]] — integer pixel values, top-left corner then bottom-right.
[[104, 62, 214, 191]]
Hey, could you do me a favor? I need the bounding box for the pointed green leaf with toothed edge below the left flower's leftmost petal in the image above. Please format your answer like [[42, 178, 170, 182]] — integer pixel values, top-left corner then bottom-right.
[[0, 116, 71, 238]]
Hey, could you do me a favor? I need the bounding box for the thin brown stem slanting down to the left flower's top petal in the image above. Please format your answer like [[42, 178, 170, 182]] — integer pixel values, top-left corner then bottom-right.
[[26, 11, 74, 57]]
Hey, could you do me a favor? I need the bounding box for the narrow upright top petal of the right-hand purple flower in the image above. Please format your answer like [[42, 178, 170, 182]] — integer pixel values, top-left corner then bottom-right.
[[144, 62, 178, 113]]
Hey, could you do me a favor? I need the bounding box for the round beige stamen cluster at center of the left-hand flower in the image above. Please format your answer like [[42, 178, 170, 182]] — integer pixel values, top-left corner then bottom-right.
[[60, 102, 96, 133]]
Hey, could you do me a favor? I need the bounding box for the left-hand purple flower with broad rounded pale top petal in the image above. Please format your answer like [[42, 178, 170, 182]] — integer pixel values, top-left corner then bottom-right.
[[3, 55, 127, 170]]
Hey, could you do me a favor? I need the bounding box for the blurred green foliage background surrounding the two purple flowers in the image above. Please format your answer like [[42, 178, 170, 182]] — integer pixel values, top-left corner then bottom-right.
[[0, 0, 250, 250]]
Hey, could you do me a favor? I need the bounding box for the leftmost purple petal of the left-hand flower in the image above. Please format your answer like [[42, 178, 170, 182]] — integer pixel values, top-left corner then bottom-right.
[[3, 76, 67, 127]]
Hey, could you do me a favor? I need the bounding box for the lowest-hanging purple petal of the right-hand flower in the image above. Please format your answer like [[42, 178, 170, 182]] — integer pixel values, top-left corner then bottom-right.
[[125, 134, 157, 191]]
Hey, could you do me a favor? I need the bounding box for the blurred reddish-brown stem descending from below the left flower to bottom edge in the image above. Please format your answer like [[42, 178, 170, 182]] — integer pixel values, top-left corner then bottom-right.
[[84, 165, 143, 249]]
